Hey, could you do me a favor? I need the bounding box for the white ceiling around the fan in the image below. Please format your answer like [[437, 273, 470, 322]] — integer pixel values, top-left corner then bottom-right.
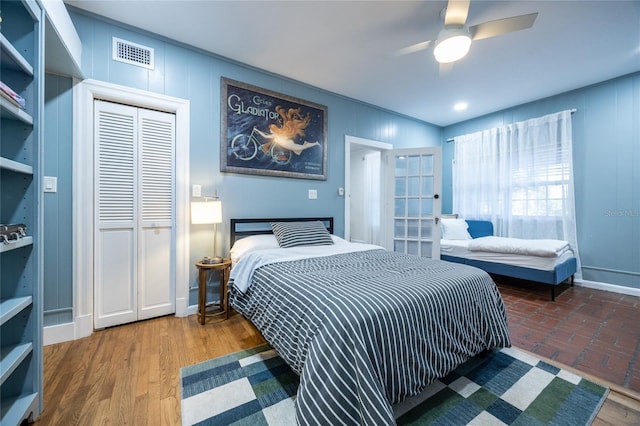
[[64, 0, 640, 126]]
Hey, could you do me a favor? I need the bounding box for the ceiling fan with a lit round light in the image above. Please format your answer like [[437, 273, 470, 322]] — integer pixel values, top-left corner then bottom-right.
[[396, 0, 538, 64]]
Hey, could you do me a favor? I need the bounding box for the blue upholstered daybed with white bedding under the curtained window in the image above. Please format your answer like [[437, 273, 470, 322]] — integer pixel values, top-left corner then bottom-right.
[[440, 218, 577, 301]]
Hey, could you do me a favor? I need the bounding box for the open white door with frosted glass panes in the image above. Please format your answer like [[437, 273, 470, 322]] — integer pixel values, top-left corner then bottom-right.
[[386, 148, 442, 259]]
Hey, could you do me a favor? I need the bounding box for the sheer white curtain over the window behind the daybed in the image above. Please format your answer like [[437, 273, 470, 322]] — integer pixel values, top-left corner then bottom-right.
[[453, 110, 580, 278]]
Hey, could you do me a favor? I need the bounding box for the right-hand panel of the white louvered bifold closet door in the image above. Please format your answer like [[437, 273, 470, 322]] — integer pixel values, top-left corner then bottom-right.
[[138, 109, 176, 319]]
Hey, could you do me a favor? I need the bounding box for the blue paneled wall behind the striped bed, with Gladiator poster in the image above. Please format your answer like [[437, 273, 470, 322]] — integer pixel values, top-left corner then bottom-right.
[[40, 8, 442, 325]]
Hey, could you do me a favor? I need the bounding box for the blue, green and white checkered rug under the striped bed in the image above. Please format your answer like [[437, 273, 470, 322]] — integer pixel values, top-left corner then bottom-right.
[[180, 345, 609, 426]]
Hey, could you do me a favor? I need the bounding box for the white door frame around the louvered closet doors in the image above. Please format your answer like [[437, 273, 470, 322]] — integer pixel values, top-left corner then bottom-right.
[[72, 79, 190, 339]]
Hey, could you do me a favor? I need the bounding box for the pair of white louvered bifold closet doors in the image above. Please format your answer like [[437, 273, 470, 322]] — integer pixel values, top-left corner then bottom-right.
[[94, 100, 176, 328]]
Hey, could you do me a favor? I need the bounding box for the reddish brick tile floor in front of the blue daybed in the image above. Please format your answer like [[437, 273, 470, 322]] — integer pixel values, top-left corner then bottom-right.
[[494, 276, 640, 392]]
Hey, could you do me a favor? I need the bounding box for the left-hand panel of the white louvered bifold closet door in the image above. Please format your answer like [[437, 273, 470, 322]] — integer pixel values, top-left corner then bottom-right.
[[94, 101, 138, 328]]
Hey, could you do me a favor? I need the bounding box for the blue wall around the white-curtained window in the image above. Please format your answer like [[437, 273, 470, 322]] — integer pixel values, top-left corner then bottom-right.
[[443, 73, 640, 288]]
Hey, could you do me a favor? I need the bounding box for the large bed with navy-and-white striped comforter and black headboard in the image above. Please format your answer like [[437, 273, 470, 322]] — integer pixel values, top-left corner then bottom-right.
[[229, 218, 511, 425]]
